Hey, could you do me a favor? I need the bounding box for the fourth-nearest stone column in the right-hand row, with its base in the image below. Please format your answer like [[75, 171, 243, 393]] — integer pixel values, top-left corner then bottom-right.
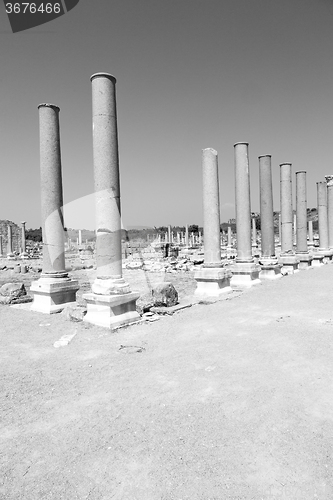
[[279, 163, 299, 274]]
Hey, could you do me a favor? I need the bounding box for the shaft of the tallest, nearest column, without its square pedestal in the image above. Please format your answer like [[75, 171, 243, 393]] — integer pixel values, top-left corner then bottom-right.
[[91, 73, 122, 279]]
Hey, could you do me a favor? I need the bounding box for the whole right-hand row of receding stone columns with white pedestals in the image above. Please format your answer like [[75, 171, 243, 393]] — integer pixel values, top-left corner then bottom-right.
[[195, 142, 333, 295]]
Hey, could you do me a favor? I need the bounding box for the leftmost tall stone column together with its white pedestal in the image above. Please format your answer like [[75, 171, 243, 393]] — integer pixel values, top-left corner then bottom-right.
[[30, 104, 79, 314]]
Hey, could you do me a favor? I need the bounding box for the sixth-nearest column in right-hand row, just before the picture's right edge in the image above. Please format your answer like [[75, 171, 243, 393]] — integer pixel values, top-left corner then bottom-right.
[[312, 181, 332, 266]]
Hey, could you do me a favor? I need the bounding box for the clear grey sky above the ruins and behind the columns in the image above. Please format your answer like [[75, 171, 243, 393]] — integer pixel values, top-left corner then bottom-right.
[[0, 0, 333, 228]]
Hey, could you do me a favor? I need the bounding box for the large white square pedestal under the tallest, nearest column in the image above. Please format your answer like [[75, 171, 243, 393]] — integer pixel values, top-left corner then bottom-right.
[[82, 292, 141, 330]]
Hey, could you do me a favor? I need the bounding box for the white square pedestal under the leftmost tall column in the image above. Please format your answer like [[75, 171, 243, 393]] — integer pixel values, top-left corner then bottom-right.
[[30, 276, 79, 314]]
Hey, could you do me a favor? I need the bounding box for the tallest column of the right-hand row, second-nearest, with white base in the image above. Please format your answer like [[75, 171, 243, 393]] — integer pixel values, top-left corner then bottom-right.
[[231, 142, 260, 289]]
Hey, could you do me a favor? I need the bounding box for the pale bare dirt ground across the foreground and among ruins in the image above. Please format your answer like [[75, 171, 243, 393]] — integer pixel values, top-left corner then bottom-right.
[[0, 264, 333, 500]]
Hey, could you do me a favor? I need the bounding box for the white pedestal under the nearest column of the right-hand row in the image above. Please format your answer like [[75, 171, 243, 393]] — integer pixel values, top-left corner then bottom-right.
[[194, 267, 232, 297]]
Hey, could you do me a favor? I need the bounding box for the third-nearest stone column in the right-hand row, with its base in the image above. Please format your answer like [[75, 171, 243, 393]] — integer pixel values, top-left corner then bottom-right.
[[259, 155, 282, 279]]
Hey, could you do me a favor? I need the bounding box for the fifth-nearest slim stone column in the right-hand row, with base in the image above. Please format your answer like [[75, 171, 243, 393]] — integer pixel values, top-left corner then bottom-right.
[[296, 170, 312, 269]]
